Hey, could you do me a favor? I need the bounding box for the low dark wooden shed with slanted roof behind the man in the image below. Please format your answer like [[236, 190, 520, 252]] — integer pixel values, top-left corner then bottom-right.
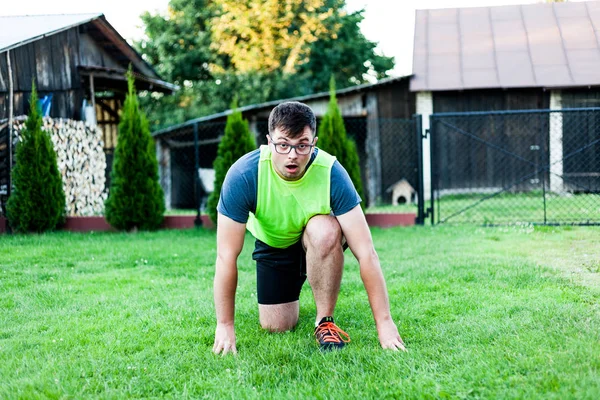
[[153, 77, 419, 208]]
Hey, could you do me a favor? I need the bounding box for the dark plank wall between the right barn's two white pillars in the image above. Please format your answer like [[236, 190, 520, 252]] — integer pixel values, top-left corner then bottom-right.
[[432, 89, 550, 191]]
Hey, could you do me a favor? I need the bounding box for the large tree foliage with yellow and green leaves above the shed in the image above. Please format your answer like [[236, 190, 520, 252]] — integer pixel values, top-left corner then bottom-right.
[[135, 0, 394, 130]]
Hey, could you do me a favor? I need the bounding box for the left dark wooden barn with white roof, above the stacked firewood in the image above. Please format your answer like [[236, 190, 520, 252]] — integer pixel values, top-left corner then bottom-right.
[[0, 14, 177, 197]]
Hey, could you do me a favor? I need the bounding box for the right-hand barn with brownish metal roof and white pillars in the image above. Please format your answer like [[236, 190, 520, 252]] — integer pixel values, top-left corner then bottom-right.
[[410, 1, 600, 195]]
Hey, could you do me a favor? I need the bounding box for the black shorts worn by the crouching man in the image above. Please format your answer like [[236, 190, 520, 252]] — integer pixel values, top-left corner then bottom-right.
[[252, 239, 306, 304]]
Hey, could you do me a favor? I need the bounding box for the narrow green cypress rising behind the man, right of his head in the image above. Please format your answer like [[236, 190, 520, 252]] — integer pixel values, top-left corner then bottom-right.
[[318, 76, 364, 204]]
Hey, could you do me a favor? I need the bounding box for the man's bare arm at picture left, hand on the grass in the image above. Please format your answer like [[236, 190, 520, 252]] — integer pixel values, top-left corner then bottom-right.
[[213, 213, 246, 355]]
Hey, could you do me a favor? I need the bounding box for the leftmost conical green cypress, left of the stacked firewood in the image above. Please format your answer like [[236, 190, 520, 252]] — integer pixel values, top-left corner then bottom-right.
[[6, 82, 66, 232]]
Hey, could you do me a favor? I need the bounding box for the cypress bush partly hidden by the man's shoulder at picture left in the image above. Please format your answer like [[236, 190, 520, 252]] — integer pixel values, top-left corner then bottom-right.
[[207, 100, 256, 225]]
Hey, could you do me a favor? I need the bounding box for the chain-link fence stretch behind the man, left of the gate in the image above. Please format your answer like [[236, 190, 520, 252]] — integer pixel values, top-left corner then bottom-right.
[[158, 117, 419, 219]]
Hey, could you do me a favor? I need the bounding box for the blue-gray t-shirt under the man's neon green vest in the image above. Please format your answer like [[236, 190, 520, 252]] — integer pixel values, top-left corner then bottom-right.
[[217, 149, 361, 224]]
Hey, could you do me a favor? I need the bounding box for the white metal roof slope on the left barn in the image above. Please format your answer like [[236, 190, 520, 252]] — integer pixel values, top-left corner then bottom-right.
[[0, 13, 102, 53]]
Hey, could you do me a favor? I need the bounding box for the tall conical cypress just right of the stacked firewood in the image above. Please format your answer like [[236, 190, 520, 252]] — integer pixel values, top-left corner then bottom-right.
[[105, 69, 165, 231]]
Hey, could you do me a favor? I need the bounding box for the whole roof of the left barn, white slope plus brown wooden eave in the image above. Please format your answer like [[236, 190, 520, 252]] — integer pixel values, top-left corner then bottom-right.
[[0, 13, 177, 92]]
